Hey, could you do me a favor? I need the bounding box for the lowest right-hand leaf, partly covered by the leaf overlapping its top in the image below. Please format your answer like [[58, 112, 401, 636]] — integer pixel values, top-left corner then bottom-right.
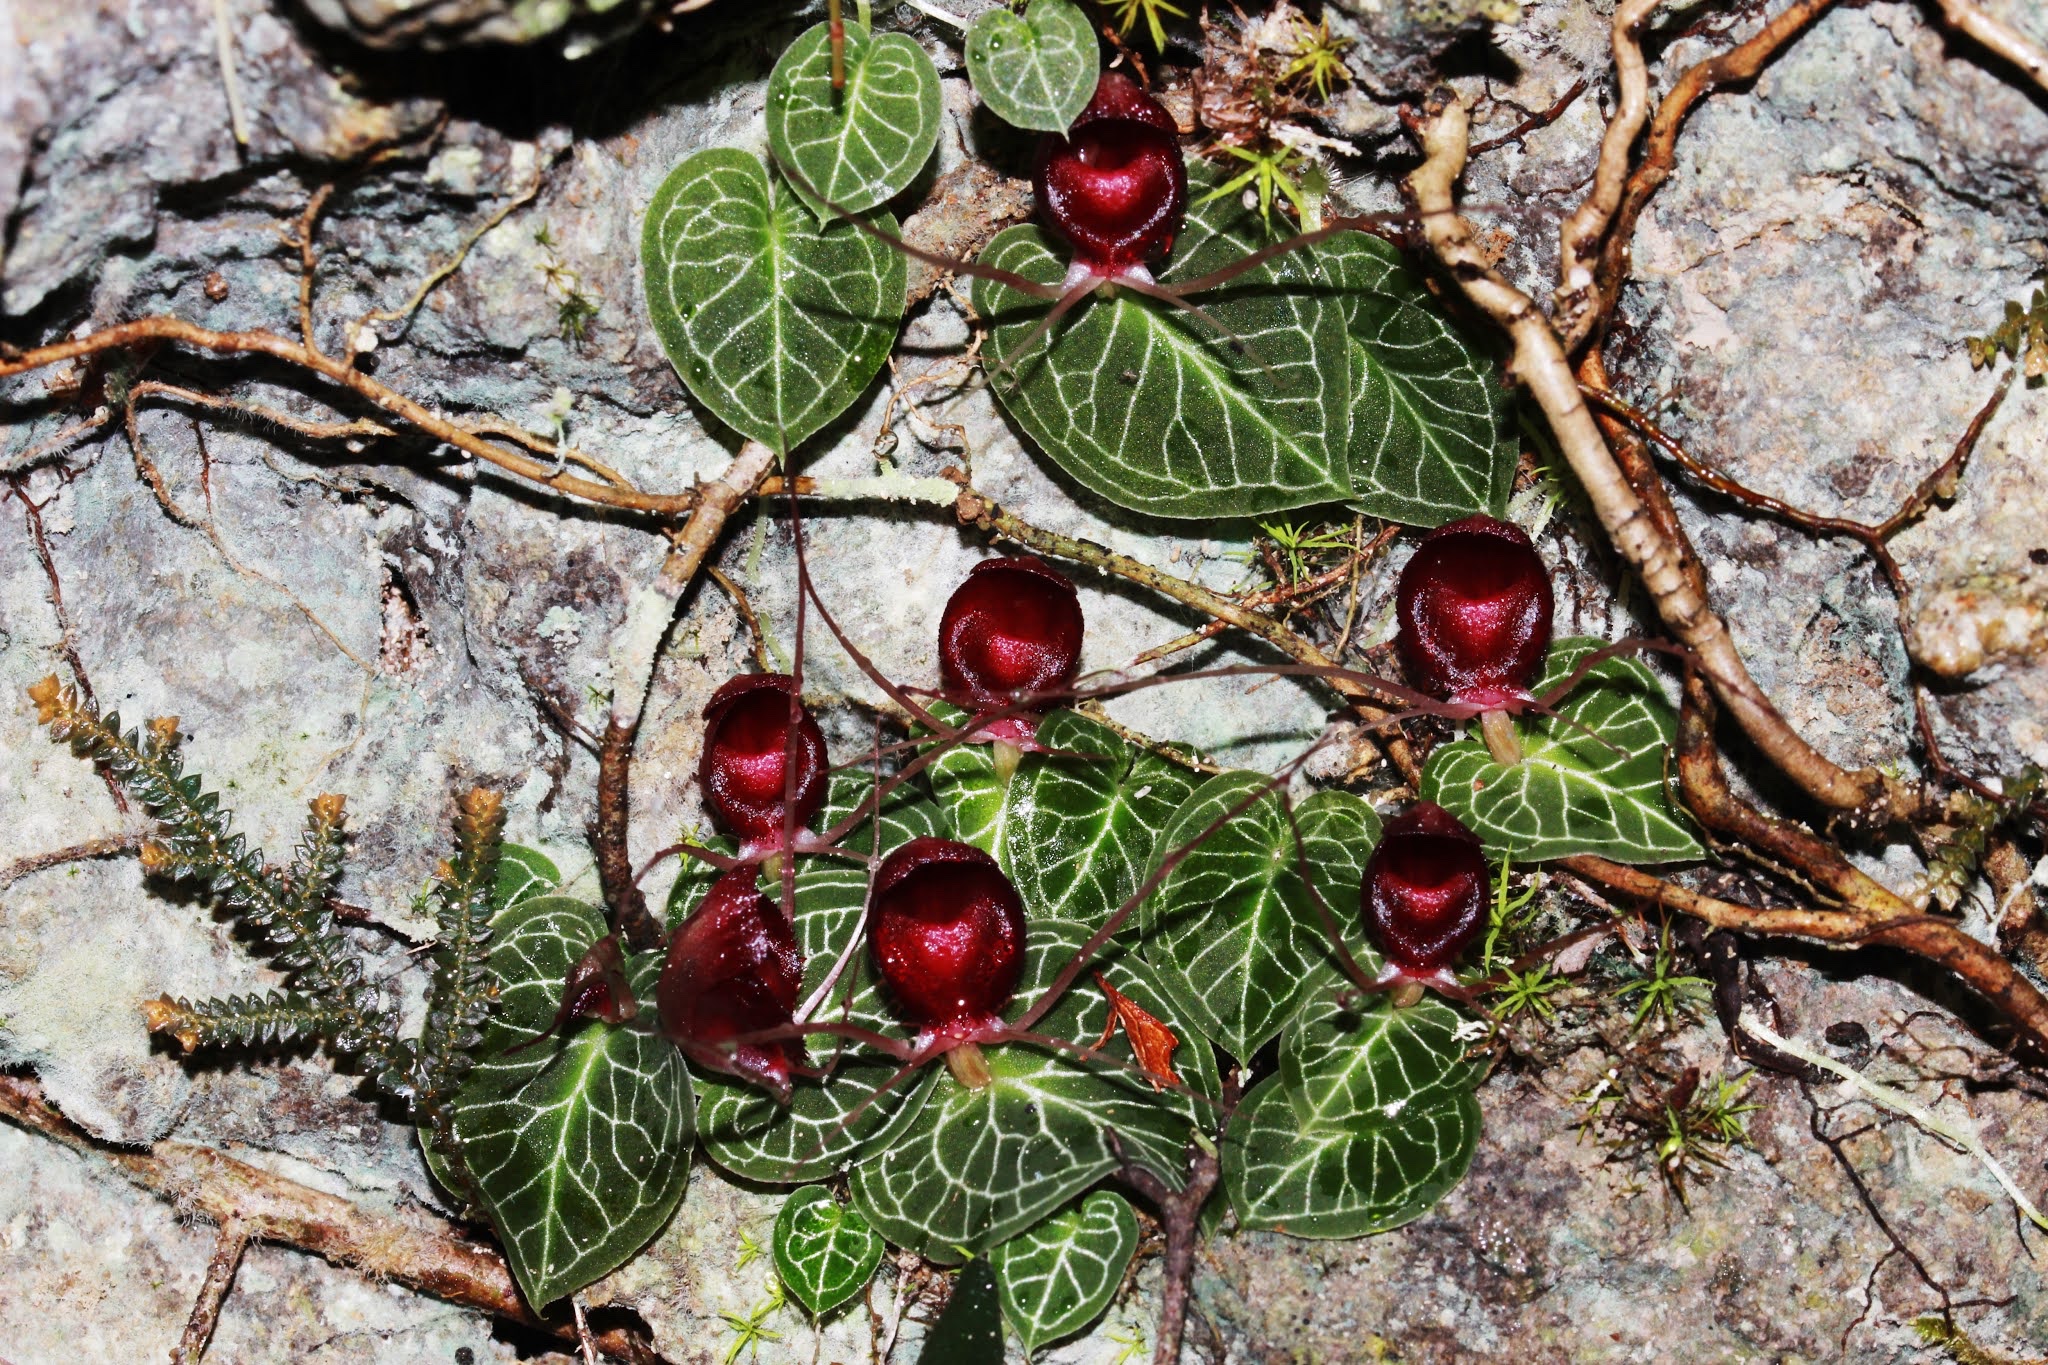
[[1221, 1076, 1479, 1238]]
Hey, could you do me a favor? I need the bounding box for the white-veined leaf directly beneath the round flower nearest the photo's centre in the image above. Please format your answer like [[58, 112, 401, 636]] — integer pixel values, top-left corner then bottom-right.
[[932, 710, 1196, 925]]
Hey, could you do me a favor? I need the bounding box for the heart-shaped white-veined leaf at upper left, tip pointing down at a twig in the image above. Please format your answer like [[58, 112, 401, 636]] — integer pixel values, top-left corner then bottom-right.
[[641, 147, 905, 454]]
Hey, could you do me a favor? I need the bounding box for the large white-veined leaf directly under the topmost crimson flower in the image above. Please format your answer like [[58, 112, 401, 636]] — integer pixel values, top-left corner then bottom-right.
[[973, 166, 1352, 518]]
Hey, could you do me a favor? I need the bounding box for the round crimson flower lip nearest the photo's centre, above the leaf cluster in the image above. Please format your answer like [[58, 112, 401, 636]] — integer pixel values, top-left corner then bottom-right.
[[938, 555, 1085, 724]]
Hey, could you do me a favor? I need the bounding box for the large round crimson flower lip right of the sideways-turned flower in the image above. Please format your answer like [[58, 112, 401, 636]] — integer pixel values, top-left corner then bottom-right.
[[868, 837, 1024, 1048]]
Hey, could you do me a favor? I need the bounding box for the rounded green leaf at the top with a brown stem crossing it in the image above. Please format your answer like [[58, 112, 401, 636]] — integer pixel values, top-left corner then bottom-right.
[[768, 25, 940, 219]]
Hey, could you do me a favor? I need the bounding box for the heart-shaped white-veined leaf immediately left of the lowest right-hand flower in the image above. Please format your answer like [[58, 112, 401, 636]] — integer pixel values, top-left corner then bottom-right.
[[1141, 772, 1380, 1060]]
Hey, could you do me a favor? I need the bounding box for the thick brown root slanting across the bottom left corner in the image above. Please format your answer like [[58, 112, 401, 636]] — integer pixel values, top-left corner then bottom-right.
[[0, 1076, 655, 1355]]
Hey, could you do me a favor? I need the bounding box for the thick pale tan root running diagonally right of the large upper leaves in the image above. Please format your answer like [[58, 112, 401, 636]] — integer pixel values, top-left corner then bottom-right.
[[1407, 90, 1890, 810]]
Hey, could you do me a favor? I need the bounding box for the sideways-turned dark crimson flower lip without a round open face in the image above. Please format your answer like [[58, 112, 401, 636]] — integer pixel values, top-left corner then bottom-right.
[[657, 868, 803, 1103]]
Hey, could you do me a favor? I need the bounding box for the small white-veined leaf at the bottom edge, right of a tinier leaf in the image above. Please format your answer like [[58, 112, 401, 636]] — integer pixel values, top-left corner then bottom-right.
[[989, 1189, 1139, 1355]]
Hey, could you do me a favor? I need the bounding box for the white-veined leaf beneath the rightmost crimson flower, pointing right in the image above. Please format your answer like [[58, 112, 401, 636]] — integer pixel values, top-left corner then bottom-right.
[[1421, 636, 1702, 864]]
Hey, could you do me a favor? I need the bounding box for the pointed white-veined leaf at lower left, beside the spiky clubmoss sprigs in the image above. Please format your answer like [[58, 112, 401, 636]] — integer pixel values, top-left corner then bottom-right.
[[455, 896, 694, 1310]]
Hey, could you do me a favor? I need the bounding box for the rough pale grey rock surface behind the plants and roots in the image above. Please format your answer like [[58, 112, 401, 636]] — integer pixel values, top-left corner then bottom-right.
[[0, 0, 2048, 1365]]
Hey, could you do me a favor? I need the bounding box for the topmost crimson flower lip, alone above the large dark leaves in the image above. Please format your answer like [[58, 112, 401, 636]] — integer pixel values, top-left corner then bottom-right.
[[1032, 72, 1188, 287]]
